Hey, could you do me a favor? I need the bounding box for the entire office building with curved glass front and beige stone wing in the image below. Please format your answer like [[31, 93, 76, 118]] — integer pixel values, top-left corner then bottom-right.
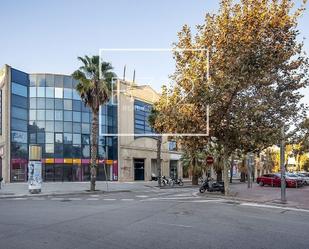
[[0, 65, 182, 182]]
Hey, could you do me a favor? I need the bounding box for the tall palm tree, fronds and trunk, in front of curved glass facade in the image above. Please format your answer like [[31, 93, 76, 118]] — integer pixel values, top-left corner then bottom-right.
[[72, 55, 116, 191]]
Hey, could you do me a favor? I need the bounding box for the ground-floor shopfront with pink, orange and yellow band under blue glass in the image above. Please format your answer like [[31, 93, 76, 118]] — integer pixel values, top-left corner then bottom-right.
[[11, 159, 118, 182]]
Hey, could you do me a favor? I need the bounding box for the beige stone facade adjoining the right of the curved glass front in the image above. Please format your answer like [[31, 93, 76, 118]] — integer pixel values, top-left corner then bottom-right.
[[117, 82, 182, 181]]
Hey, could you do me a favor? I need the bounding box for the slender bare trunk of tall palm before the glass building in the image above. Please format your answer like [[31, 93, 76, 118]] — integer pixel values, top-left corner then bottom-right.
[[90, 111, 99, 191]]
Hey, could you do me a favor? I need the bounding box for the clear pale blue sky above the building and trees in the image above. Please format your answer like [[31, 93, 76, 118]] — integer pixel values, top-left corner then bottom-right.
[[0, 0, 309, 104]]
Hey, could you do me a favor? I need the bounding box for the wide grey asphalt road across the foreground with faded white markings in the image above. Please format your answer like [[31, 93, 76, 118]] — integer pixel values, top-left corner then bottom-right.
[[0, 189, 309, 249]]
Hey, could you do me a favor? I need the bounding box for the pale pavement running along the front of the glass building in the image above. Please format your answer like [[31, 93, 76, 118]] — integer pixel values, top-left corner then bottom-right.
[[0, 181, 157, 199]]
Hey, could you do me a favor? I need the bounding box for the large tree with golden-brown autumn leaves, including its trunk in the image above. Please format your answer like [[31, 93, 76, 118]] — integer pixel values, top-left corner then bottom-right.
[[153, 0, 308, 194]]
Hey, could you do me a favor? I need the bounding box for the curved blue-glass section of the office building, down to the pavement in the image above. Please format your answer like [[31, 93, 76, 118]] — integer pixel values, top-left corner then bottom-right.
[[10, 68, 118, 182]]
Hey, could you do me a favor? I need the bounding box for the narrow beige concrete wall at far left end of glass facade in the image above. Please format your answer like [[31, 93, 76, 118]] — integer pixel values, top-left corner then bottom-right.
[[0, 65, 11, 182]]
